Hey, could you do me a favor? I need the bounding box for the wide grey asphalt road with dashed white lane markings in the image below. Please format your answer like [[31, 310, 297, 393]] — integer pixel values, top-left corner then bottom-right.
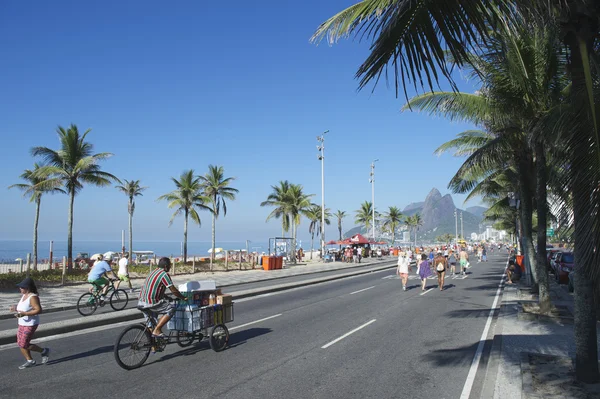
[[0, 255, 506, 398]]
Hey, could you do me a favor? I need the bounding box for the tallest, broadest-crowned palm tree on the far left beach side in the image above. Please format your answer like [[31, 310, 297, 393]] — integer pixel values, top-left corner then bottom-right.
[[31, 124, 120, 269]]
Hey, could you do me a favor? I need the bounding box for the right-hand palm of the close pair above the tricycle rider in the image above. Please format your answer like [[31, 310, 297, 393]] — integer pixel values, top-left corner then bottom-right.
[[200, 165, 238, 271]]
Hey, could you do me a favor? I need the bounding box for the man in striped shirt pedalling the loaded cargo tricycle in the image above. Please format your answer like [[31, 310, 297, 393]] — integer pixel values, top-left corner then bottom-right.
[[138, 258, 186, 337]]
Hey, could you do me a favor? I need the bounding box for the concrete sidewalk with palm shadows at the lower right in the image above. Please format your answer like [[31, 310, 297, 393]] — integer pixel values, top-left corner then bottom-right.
[[486, 278, 600, 399]]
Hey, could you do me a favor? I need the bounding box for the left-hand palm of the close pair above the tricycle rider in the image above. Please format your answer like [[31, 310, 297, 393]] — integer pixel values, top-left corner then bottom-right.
[[157, 169, 212, 263]]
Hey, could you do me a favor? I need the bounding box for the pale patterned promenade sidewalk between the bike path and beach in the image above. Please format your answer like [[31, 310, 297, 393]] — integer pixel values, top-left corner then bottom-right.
[[0, 257, 394, 319]]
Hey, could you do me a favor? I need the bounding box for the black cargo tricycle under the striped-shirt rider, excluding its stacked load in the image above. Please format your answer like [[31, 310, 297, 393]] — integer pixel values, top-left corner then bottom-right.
[[114, 301, 233, 370]]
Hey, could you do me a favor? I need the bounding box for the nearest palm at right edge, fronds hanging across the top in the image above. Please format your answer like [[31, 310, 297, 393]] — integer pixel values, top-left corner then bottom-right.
[[313, 0, 600, 383]]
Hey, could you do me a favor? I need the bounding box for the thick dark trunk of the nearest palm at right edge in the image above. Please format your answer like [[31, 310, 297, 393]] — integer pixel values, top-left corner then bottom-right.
[[565, 26, 600, 383]]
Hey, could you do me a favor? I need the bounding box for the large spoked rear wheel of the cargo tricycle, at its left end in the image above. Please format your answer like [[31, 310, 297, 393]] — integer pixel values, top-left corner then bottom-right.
[[114, 324, 152, 370]]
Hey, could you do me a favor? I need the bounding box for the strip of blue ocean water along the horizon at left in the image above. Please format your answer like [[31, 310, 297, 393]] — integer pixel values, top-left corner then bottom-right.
[[0, 240, 269, 264]]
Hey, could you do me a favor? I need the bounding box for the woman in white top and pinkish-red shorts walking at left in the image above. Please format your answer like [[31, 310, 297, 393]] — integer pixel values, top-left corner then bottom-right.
[[10, 277, 50, 370]]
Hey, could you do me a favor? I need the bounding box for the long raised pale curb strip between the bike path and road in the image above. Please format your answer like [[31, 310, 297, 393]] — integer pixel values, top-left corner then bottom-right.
[[0, 262, 396, 345]]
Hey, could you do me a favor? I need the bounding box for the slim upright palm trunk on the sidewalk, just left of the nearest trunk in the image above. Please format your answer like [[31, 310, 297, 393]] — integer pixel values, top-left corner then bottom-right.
[[535, 141, 551, 312]]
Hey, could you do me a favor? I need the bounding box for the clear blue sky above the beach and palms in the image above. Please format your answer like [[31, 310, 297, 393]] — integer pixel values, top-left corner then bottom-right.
[[0, 0, 477, 241]]
